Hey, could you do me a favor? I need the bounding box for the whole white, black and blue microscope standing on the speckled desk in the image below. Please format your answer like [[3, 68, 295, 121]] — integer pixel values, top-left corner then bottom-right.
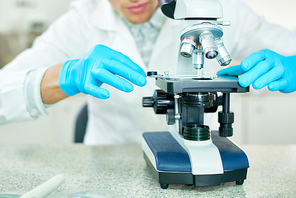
[[142, 0, 249, 189]]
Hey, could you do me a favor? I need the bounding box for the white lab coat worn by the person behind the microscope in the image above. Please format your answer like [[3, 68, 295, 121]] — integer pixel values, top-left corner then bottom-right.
[[0, 0, 296, 144]]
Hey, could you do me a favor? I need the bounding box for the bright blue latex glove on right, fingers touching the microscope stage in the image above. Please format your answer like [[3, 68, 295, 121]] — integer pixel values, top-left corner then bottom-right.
[[217, 49, 296, 93]]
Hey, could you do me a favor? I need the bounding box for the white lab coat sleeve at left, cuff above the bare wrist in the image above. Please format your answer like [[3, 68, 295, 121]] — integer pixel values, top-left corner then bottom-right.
[[0, 3, 87, 125]]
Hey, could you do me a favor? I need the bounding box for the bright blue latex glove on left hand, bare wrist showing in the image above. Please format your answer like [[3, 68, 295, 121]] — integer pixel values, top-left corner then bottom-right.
[[59, 45, 146, 99]]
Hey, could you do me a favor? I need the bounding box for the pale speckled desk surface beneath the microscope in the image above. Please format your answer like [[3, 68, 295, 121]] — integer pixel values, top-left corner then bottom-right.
[[0, 144, 296, 198]]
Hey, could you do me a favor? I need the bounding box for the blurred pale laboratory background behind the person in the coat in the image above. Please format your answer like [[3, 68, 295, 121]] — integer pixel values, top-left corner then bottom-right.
[[0, 0, 296, 144]]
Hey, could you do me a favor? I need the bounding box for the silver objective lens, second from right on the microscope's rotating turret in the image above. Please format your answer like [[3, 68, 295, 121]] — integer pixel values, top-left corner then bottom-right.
[[199, 31, 218, 59]]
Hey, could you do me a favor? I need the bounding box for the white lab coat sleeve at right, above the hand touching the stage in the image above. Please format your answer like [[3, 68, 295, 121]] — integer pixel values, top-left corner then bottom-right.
[[223, 0, 296, 61]]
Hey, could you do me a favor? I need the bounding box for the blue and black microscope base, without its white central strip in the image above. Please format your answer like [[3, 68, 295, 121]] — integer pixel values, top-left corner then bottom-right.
[[143, 132, 249, 189]]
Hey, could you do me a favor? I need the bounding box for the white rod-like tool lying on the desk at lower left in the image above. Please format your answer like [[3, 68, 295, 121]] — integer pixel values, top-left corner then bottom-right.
[[20, 174, 65, 198]]
